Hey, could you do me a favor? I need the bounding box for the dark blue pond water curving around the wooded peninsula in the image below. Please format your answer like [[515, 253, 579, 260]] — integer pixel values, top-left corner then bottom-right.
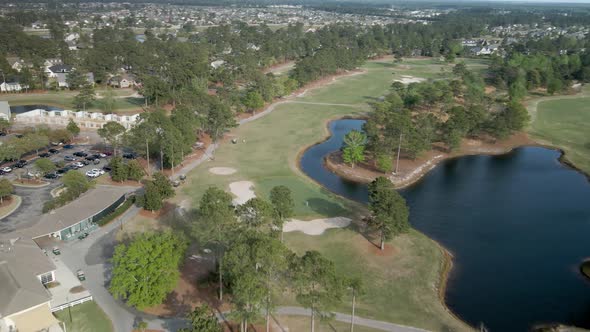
[[301, 120, 590, 332]]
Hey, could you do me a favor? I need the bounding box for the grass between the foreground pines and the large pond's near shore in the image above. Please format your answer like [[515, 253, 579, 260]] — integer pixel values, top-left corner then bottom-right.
[[285, 229, 467, 331]]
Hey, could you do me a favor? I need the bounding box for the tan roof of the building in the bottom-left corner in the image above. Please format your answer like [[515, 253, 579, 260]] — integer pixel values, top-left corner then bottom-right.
[[0, 237, 55, 317]]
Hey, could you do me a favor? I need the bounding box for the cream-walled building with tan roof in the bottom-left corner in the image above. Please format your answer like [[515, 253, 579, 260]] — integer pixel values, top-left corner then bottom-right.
[[0, 233, 63, 332]]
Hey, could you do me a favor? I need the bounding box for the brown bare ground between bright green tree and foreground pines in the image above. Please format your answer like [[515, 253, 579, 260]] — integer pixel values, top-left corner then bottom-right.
[[144, 248, 230, 317]]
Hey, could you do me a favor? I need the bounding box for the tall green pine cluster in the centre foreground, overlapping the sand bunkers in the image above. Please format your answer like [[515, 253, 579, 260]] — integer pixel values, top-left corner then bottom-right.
[[193, 186, 359, 331]]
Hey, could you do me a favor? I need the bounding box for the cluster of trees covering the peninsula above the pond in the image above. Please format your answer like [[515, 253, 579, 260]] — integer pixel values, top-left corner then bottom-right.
[[358, 63, 528, 172]]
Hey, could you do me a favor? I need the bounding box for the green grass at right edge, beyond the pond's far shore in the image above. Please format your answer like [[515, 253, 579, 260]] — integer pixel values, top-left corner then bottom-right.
[[530, 97, 590, 174]]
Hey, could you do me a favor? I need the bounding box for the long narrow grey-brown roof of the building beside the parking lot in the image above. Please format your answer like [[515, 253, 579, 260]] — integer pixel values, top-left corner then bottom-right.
[[27, 186, 135, 238]]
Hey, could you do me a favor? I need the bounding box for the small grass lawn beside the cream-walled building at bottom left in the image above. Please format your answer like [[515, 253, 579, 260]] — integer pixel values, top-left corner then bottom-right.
[[55, 301, 113, 332]]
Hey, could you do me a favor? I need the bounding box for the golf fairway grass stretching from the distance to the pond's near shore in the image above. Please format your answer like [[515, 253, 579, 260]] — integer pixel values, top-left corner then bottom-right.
[[174, 57, 474, 331]]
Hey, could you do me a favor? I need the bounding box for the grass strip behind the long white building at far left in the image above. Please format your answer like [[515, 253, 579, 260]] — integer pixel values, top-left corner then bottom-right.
[[0, 89, 144, 113]]
